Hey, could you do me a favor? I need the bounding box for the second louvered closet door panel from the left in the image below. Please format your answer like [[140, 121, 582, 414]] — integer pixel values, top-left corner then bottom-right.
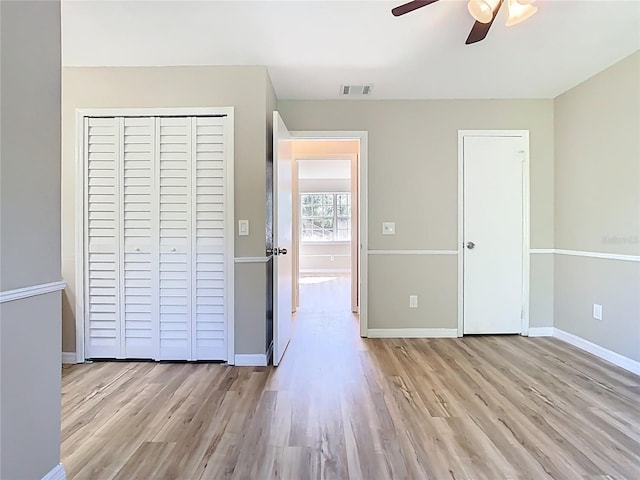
[[120, 117, 159, 358]]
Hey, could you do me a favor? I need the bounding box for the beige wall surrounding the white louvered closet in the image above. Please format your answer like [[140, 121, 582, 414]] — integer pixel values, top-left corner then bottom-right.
[[62, 66, 275, 353]]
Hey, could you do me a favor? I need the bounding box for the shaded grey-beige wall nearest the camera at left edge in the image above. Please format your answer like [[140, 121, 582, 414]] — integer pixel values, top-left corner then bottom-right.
[[0, 0, 61, 480]]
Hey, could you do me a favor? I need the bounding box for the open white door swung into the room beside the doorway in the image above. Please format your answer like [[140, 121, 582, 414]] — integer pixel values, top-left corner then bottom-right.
[[273, 112, 293, 365]]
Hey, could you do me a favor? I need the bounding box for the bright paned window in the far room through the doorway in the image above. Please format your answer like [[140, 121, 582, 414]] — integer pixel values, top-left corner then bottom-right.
[[300, 193, 351, 242]]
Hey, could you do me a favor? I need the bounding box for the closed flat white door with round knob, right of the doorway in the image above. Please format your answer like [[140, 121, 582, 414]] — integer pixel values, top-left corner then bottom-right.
[[463, 136, 526, 334]]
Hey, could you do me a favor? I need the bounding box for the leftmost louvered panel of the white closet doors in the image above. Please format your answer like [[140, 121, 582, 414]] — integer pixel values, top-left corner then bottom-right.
[[84, 118, 122, 358]]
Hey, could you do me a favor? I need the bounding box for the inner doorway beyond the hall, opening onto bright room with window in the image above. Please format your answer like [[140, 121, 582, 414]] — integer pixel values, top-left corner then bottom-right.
[[292, 139, 360, 322]]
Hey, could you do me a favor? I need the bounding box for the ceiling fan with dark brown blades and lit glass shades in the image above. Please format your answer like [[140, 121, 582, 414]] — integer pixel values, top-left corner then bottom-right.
[[391, 0, 538, 45]]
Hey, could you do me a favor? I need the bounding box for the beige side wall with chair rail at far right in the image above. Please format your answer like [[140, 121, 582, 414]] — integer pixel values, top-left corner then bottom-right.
[[554, 52, 640, 360]]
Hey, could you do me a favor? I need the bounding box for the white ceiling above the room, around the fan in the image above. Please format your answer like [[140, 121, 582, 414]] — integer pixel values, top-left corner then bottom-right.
[[62, 0, 640, 99]]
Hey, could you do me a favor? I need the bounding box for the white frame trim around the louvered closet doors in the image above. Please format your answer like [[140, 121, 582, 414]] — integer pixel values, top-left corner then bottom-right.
[[75, 107, 235, 365]]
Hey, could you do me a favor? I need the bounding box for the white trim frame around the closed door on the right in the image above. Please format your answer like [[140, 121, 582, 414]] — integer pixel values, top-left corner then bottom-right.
[[458, 130, 531, 337]]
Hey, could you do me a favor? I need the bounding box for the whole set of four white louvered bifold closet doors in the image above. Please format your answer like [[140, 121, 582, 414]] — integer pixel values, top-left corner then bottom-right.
[[84, 116, 233, 360]]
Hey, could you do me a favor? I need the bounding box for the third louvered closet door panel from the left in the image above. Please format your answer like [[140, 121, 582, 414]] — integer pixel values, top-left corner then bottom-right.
[[156, 117, 195, 360]]
